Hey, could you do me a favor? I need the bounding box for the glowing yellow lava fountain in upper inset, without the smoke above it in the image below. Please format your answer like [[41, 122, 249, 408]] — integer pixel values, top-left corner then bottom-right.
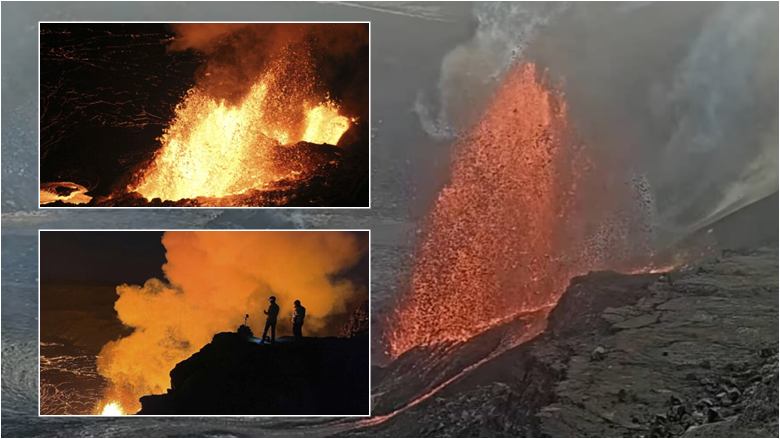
[[128, 55, 352, 201]]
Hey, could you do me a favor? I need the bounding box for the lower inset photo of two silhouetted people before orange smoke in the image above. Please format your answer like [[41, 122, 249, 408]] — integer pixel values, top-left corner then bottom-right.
[[38, 230, 370, 416]]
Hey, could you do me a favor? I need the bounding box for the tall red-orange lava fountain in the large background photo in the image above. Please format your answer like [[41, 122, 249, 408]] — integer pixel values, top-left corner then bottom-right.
[[385, 64, 648, 357]]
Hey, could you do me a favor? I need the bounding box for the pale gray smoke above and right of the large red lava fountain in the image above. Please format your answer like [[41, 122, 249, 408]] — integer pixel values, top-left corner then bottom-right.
[[416, 2, 778, 251]]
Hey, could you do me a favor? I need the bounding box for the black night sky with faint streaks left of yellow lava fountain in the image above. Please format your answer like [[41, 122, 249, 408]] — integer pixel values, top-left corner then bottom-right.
[[40, 23, 202, 194]]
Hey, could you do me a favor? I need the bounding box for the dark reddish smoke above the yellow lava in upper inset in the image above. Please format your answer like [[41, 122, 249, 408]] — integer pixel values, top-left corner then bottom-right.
[[164, 23, 368, 118]]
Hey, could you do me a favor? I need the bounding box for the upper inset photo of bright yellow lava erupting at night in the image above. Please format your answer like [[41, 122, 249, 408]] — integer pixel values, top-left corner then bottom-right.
[[39, 22, 370, 208]]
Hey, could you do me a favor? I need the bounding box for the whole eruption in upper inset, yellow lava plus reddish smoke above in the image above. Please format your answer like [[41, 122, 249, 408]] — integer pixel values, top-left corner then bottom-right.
[[126, 23, 368, 201]]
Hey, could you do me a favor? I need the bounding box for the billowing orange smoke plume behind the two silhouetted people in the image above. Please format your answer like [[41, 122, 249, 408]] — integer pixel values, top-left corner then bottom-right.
[[98, 231, 367, 412]]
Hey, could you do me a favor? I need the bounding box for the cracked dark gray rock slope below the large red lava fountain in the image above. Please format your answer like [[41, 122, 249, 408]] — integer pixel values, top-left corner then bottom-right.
[[350, 248, 778, 437]]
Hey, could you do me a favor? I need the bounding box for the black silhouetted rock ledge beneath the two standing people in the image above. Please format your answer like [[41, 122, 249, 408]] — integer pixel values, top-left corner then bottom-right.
[[138, 332, 368, 415]]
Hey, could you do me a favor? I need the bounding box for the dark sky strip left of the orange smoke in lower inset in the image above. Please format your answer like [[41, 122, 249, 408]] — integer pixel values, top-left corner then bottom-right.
[[40, 231, 165, 284]]
